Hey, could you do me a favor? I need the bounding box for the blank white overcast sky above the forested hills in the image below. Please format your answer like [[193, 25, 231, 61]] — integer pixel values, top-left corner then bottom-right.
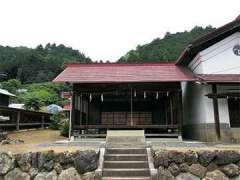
[[0, 0, 240, 61]]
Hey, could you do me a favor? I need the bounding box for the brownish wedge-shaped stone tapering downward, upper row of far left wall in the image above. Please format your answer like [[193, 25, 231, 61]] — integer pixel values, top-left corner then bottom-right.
[[15, 153, 31, 172]]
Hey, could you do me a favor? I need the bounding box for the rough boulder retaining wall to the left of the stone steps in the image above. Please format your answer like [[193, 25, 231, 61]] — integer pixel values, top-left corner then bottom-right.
[[0, 150, 98, 180]]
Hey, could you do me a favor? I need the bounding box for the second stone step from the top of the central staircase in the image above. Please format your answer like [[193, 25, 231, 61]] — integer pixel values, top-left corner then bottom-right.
[[104, 154, 148, 161]]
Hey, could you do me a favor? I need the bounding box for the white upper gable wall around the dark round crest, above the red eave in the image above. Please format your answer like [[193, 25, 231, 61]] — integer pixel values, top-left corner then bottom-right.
[[189, 32, 240, 74]]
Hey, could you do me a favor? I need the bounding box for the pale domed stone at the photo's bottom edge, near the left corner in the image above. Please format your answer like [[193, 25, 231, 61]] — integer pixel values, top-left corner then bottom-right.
[[4, 168, 30, 180]]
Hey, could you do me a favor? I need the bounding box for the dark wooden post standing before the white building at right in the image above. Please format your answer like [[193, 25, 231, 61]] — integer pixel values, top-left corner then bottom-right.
[[212, 84, 221, 140]]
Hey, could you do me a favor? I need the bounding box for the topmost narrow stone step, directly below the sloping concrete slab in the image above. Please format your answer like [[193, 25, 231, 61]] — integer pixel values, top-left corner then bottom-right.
[[106, 148, 147, 154]]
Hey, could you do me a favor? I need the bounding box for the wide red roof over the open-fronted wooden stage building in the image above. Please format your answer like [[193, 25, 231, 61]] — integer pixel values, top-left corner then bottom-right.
[[53, 63, 195, 83]]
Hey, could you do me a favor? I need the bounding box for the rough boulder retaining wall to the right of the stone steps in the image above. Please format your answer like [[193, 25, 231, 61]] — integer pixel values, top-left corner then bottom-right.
[[153, 150, 240, 180]]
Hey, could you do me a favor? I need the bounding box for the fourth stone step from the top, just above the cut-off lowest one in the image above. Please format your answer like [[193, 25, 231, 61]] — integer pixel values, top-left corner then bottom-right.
[[103, 168, 150, 177]]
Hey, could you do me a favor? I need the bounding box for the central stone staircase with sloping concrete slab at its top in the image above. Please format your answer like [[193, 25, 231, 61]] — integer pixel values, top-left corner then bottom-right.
[[95, 131, 157, 180]]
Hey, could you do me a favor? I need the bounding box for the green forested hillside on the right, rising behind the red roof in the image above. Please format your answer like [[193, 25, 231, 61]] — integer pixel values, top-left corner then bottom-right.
[[118, 26, 214, 63]]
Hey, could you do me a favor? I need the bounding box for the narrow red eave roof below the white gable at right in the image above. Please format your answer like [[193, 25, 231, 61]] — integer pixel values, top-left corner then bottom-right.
[[198, 74, 240, 83]]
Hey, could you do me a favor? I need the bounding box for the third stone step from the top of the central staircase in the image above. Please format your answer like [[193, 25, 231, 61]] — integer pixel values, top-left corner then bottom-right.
[[103, 161, 149, 169]]
